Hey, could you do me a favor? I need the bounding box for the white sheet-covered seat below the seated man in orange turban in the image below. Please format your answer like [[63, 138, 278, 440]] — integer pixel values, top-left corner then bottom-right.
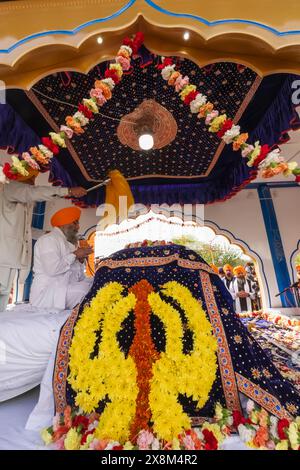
[[0, 305, 70, 402]]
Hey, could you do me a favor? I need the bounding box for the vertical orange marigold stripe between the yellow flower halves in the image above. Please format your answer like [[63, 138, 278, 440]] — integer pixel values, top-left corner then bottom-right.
[[129, 279, 159, 440]]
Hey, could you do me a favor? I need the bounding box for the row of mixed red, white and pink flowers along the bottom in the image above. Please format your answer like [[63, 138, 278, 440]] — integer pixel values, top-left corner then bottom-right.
[[41, 400, 300, 450]]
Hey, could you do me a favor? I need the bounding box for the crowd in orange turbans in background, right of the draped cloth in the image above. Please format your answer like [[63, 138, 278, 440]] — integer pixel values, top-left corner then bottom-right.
[[211, 262, 261, 313]]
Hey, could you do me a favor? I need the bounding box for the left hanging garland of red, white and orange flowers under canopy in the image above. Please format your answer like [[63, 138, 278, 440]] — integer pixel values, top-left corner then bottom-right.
[[0, 32, 144, 183]]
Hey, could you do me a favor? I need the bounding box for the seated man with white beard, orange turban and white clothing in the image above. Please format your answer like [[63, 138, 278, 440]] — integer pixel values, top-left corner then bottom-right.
[[30, 207, 92, 310]]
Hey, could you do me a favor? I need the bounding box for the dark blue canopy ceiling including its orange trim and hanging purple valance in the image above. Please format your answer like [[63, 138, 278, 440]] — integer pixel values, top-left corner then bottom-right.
[[3, 47, 299, 205]]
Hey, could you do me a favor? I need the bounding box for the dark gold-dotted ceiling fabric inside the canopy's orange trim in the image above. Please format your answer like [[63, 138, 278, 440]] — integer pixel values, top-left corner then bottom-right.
[[34, 51, 257, 180]]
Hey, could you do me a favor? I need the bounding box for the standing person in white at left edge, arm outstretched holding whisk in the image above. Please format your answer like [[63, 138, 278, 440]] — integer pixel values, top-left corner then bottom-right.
[[0, 172, 86, 312]]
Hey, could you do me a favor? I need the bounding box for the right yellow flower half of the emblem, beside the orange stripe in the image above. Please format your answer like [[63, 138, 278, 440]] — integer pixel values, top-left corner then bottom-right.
[[148, 281, 217, 441]]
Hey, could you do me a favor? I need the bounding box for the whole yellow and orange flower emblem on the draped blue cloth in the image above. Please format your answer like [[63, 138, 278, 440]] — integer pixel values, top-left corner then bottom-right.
[[68, 280, 217, 442]]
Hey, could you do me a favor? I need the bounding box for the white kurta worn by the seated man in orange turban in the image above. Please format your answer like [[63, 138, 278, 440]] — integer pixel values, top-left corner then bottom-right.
[[30, 227, 92, 310]]
